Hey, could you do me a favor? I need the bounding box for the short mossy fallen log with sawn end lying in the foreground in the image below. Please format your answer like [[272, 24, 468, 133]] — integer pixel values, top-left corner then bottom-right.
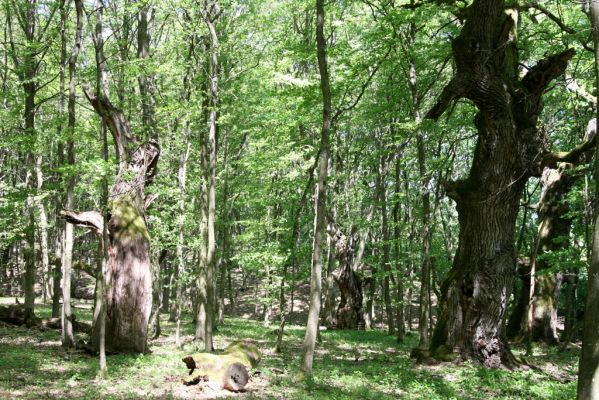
[[183, 340, 260, 392]]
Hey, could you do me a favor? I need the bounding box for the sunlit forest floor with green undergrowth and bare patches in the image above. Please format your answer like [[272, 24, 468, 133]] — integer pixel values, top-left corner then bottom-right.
[[0, 298, 579, 400]]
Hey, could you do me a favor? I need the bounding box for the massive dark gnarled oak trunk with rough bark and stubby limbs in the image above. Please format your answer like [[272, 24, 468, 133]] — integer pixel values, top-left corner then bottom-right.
[[427, 0, 574, 367]]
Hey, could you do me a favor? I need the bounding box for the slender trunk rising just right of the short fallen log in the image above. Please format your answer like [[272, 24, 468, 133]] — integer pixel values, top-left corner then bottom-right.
[[301, 0, 332, 375]]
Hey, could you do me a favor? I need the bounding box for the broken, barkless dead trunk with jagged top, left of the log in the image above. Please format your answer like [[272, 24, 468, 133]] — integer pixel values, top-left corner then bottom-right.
[[63, 93, 160, 353]]
